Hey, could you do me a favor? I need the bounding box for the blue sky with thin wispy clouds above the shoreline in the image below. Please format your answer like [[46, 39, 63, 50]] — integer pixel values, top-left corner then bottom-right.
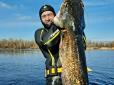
[[0, 0, 114, 41]]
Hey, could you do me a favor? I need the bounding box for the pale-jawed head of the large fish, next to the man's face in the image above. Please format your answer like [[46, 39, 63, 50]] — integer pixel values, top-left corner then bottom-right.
[[54, 2, 74, 29]]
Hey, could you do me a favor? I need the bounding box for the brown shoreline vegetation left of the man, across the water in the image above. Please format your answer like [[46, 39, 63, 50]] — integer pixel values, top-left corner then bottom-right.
[[0, 39, 38, 49]]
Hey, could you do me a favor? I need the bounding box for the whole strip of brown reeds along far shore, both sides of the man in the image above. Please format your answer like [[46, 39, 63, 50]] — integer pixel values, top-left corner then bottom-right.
[[0, 39, 114, 49]]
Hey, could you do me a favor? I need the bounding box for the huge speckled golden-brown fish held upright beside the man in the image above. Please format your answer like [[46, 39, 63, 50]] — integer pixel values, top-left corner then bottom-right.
[[54, 0, 88, 85]]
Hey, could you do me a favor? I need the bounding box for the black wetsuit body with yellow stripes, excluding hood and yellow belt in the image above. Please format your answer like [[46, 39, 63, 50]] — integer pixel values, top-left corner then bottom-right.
[[35, 24, 62, 85]]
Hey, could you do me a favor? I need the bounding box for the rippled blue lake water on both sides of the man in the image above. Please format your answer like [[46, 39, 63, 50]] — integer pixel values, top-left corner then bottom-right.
[[0, 50, 114, 85]]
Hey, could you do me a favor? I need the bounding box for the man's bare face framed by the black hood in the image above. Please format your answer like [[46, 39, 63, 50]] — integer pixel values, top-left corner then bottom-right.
[[41, 11, 54, 25]]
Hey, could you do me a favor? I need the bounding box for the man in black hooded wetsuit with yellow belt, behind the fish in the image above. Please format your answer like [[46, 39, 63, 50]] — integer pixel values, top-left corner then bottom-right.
[[35, 5, 84, 85]]
